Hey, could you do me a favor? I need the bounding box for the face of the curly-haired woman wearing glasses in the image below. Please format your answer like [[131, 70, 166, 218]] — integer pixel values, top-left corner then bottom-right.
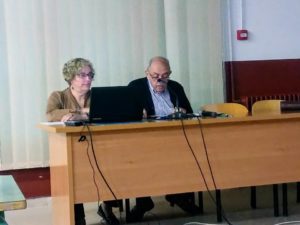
[[71, 66, 94, 93]]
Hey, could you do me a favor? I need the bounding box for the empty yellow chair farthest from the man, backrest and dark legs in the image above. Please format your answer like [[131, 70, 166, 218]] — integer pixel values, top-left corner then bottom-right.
[[252, 100, 288, 216]]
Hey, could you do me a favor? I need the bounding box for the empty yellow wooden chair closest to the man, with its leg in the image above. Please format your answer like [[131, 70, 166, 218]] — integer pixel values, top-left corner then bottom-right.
[[201, 103, 252, 222]]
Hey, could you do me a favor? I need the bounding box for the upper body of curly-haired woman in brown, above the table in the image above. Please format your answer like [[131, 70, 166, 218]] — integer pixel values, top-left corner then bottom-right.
[[47, 58, 94, 122]]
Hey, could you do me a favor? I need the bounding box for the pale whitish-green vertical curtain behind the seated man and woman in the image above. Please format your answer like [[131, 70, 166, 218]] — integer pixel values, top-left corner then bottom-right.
[[0, 0, 224, 170]]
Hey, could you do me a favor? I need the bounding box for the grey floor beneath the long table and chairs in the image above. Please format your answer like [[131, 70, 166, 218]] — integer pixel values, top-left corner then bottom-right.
[[5, 184, 300, 225]]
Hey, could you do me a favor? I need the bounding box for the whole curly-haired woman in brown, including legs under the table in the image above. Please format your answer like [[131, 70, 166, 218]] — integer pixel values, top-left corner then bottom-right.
[[46, 58, 119, 225]]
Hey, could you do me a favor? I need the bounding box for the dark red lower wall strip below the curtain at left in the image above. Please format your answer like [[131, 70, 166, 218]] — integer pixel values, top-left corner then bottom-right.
[[0, 167, 51, 198]]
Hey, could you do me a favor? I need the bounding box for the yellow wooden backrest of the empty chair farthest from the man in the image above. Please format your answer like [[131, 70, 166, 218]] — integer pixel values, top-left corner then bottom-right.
[[252, 100, 282, 116]]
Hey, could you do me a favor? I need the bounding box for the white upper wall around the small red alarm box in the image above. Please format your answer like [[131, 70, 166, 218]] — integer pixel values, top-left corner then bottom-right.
[[223, 0, 300, 61]]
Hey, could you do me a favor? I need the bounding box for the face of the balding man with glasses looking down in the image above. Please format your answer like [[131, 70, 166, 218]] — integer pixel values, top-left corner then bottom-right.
[[146, 61, 171, 92]]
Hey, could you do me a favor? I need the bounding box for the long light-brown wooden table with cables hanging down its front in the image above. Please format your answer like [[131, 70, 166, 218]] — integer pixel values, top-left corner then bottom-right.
[[39, 113, 300, 225]]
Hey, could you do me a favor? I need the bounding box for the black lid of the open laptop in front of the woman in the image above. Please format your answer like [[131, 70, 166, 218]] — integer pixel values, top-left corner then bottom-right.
[[89, 86, 143, 123]]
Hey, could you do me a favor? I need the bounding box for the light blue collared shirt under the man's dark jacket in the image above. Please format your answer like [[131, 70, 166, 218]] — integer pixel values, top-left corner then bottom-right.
[[148, 80, 174, 116]]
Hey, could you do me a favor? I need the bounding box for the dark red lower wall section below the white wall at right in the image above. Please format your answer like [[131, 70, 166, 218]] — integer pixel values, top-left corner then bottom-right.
[[225, 59, 300, 102]]
